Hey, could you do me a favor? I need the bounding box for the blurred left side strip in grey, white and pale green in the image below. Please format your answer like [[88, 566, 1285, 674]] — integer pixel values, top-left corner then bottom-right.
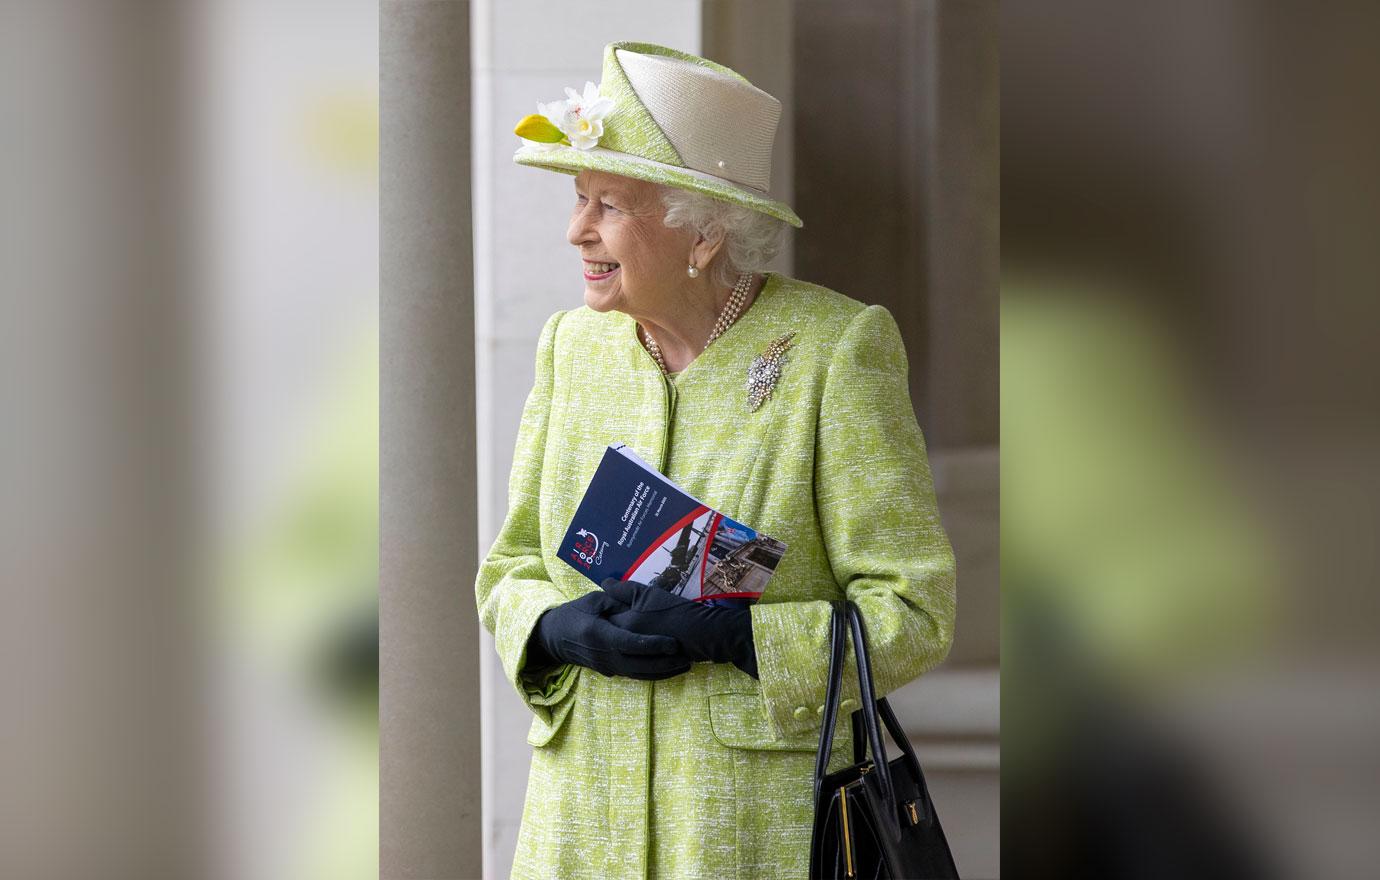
[[0, 0, 378, 880]]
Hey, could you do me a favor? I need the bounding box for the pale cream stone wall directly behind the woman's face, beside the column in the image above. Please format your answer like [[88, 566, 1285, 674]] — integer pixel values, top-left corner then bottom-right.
[[471, 0, 701, 879]]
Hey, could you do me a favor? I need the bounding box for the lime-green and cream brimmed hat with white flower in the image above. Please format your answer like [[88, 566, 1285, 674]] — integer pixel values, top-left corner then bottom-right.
[[513, 43, 803, 226]]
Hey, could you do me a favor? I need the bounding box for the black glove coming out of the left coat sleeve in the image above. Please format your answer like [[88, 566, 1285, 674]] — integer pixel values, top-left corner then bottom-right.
[[524, 590, 691, 681]]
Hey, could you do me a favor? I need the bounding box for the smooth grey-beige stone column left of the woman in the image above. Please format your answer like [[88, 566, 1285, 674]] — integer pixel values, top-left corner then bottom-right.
[[378, 0, 480, 879]]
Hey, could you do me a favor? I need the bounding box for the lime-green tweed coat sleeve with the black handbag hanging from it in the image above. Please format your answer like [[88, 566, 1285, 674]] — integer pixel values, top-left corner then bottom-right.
[[752, 306, 955, 735]]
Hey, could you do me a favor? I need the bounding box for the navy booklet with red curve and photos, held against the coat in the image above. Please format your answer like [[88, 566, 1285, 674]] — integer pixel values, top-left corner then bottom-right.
[[560, 443, 785, 606]]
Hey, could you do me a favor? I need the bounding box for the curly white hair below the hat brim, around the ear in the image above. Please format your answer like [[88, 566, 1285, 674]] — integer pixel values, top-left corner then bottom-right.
[[660, 185, 785, 287]]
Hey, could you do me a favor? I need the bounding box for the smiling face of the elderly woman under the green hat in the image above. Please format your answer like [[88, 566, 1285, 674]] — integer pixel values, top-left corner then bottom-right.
[[566, 171, 693, 317]]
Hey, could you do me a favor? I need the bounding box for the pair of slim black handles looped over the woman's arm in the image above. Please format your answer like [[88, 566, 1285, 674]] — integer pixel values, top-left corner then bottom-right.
[[814, 600, 914, 839]]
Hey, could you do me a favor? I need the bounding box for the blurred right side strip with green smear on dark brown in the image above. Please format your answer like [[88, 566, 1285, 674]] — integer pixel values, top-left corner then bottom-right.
[[1001, 0, 1380, 880]]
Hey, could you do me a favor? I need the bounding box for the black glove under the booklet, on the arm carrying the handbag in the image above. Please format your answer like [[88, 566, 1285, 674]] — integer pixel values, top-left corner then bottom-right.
[[602, 578, 758, 679]]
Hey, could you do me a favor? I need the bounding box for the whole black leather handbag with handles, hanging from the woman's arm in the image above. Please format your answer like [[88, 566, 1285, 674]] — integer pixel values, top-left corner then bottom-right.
[[810, 601, 958, 880]]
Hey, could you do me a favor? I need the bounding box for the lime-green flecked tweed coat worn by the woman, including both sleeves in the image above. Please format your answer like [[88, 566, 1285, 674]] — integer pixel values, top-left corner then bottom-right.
[[476, 273, 954, 880]]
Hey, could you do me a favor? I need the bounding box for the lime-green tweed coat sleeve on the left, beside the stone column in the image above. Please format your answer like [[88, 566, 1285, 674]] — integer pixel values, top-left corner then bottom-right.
[[475, 312, 578, 724]]
